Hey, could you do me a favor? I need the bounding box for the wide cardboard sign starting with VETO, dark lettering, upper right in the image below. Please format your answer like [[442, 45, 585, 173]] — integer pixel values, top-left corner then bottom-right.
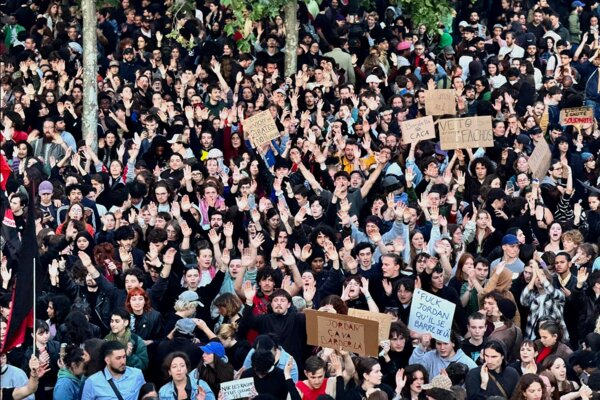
[[438, 116, 494, 150]]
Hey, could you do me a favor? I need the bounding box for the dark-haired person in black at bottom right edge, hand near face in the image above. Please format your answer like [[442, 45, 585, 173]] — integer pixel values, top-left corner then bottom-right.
[[465, 340, 520, 400]]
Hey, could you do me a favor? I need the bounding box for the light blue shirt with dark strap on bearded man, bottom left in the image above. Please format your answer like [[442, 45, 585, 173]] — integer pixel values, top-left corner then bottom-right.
[[81, 367, 146, 400]]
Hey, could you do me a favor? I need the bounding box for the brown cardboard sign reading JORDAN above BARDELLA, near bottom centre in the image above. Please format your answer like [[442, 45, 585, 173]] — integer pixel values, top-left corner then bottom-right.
[[304, 310, 379, 357]]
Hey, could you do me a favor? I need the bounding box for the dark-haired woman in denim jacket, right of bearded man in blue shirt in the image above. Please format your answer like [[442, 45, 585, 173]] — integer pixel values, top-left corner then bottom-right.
[[158, 352, 215, 400]]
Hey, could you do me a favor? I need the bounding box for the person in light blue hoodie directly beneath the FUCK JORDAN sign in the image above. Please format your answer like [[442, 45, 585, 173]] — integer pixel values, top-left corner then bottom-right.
[[409, 332, 477, 376]]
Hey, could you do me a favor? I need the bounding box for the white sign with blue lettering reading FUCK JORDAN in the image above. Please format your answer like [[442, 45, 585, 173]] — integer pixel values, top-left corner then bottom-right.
[[408, 289, 456, 343]]
